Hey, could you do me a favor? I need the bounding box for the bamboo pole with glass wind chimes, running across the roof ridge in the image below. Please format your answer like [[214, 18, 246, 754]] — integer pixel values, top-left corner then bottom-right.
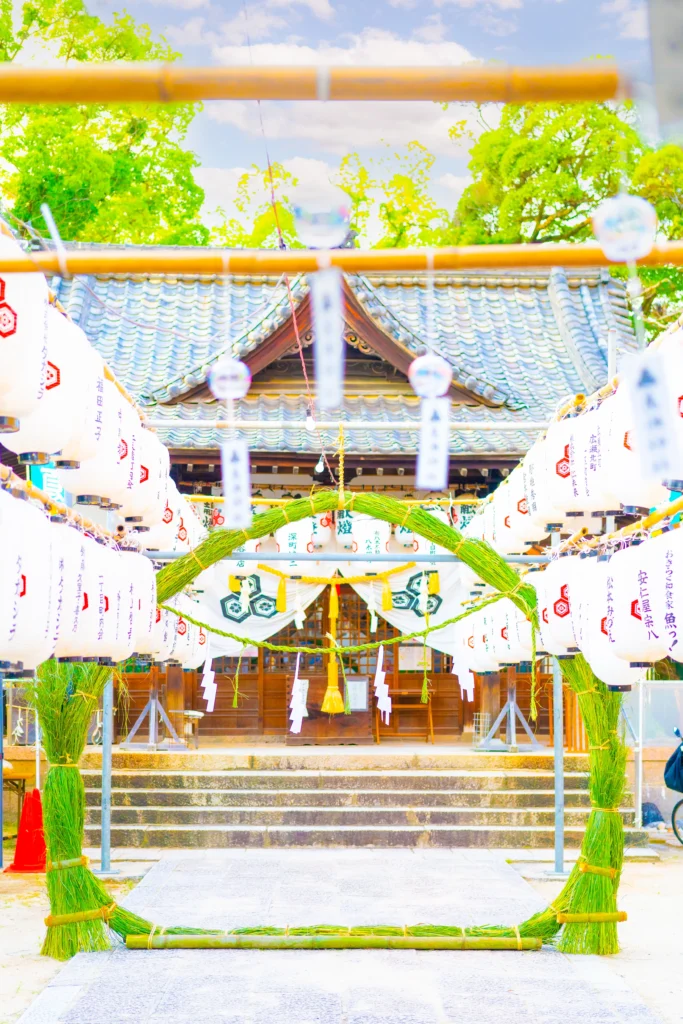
[[0, 237, 683, 278]]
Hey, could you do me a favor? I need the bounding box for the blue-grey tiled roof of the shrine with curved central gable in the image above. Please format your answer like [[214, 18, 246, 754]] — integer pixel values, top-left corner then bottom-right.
[[51, 247, 635, 453]]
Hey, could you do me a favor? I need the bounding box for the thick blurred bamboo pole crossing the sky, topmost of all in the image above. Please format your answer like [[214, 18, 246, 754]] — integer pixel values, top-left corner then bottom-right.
[[0, 62, 630, 103]]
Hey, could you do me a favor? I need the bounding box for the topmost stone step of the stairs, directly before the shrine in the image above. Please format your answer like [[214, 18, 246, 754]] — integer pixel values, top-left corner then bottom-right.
[[81, 743, 588, 772]]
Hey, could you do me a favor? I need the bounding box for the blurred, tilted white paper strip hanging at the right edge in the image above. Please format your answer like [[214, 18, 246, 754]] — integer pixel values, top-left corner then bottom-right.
[[624, 349, 683, 481]]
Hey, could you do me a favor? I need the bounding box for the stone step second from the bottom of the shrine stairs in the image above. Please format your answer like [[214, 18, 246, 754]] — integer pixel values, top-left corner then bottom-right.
[[87, 806, 634, 829]]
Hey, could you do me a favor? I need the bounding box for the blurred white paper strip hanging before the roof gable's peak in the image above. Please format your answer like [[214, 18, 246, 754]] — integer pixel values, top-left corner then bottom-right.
[[308, 267, 344, 410]]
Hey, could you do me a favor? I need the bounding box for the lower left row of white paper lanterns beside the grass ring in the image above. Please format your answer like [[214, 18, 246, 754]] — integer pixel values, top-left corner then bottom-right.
[[0, 490, 206, 675]]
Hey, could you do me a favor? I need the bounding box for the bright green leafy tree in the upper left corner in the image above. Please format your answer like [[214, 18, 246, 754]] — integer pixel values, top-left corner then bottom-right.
[[0, 0, 209, 245]]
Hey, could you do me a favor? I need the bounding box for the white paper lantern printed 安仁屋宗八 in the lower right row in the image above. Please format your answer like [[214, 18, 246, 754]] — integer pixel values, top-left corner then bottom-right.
[[608, 544, 668, 666]]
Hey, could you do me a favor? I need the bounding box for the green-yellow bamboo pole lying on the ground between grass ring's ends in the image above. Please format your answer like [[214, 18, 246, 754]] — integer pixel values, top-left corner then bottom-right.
[[126, 934, 542, 949]]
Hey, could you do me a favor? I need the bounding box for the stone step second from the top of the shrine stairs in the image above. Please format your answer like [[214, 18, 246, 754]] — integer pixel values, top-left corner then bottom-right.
[[82, 766, 588, 791]]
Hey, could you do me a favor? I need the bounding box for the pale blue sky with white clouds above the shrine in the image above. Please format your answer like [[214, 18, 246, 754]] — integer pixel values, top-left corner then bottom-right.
[[83, 0, 651, 232]]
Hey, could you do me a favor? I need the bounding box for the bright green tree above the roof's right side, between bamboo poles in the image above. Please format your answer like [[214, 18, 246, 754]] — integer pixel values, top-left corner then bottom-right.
[[456, 103, 645, 244]]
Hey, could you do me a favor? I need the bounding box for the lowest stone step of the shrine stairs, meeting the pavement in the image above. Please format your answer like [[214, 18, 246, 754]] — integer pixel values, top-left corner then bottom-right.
[[85, 824, 648, 850]]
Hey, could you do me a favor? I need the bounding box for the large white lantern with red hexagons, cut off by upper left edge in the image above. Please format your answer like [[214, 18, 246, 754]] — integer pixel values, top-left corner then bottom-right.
[[0, 231, 49, 419]]
